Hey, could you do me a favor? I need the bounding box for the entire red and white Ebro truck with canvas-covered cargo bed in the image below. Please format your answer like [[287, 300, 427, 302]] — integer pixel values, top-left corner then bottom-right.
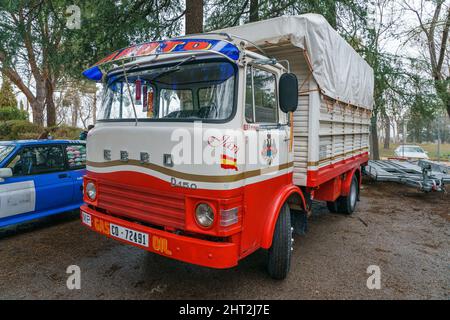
[[81, 15, 374, 279]]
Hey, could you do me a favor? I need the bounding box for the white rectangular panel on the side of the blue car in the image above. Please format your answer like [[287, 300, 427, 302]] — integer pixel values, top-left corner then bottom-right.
[[0, 181, 36, 218]]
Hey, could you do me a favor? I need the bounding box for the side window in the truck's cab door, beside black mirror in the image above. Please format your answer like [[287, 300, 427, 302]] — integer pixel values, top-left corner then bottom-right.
[[245, 66, 278, 124]]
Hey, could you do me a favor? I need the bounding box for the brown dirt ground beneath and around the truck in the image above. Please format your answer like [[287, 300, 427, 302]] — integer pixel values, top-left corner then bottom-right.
[[0, 181, 450, 300]]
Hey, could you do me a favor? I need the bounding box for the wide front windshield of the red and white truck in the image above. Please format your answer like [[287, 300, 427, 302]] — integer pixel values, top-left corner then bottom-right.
[[99, 61, 236, 121]]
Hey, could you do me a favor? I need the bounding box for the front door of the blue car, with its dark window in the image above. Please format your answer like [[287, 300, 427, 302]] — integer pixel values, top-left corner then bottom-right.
[[9, 144, 73, 212]]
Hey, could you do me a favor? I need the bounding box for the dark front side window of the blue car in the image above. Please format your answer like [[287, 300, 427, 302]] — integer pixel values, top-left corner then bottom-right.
[[8, 146, 65, 176]]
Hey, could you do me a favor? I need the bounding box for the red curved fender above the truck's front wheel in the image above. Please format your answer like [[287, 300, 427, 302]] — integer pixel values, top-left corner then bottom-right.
[[261, 185, 306, 249]]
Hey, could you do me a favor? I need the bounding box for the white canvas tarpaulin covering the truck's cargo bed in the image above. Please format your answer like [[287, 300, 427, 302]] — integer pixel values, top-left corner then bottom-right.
[[216, 14, 374, 109]]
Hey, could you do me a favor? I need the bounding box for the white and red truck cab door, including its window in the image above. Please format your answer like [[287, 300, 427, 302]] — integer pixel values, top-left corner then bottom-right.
[[241, 66, 289, 254]]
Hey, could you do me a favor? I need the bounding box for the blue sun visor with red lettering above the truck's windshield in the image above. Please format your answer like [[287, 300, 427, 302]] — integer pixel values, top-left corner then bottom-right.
[[83, 39, 239, 81]]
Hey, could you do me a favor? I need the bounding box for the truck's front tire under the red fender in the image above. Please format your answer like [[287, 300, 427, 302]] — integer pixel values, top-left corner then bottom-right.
[[267, 204, 293, 280]]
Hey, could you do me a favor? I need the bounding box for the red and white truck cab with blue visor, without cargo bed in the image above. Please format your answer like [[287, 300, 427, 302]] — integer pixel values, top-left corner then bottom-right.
[[81, 15, 372, 279]]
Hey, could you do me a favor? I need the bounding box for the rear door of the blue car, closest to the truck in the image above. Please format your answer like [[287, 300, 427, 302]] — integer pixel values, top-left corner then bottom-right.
[[64, 143, 86, 204]]
